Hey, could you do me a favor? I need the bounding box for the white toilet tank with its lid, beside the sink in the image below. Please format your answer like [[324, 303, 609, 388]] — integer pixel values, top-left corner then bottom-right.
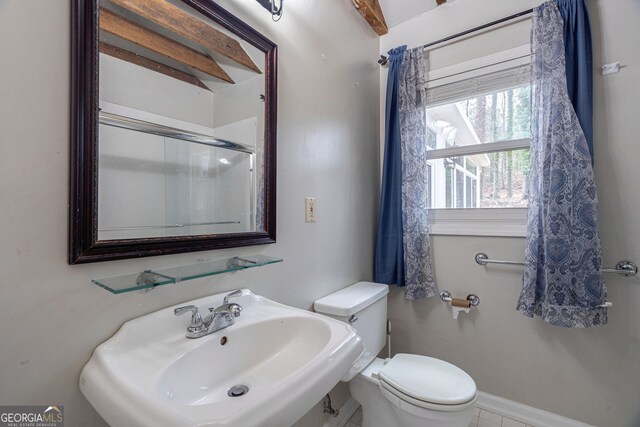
[[313, 282, 389, 381]]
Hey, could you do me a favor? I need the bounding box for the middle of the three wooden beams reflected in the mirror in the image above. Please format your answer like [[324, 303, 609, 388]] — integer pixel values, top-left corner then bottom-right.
[[100, 7, 233, 83]]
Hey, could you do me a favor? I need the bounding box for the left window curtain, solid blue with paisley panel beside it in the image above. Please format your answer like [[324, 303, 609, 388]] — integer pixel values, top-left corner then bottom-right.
[[374, 46, 436, 299]]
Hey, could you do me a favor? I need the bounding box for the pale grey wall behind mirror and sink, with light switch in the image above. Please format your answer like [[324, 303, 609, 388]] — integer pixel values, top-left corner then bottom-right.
[[0, 0, 379, 426]]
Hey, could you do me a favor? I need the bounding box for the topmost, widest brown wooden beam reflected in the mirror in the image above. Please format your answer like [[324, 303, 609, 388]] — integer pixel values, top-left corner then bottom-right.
[[111, 0, 262, 74]]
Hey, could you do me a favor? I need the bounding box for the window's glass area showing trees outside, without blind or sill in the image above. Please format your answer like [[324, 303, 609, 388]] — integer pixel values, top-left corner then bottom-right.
[[426, 85, 531, 209]]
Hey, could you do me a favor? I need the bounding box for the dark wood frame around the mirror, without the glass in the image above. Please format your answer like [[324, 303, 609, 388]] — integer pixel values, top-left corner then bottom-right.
[[69, 0, 277, 264]]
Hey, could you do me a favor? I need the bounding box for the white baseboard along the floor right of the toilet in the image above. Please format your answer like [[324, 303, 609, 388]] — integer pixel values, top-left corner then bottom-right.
[[476, 391, 594, 427]]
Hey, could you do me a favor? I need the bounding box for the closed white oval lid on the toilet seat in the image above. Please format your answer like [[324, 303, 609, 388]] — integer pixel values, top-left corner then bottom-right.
[[378, 354, 476, 405]]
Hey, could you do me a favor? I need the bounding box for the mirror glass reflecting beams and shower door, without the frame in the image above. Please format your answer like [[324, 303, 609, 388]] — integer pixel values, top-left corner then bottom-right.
[[97, 0, 265, 241]]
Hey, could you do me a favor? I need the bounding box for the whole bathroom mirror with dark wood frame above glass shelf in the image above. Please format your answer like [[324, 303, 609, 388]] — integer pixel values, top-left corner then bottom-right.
[[69, 0, 277, 264]]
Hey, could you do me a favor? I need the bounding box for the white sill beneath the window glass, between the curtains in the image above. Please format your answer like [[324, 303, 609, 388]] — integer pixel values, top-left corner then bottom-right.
[[429, 208, 527, 237]]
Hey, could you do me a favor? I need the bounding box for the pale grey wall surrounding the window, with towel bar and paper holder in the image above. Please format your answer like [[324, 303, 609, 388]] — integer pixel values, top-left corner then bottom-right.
[[380, 0, 640, 427]]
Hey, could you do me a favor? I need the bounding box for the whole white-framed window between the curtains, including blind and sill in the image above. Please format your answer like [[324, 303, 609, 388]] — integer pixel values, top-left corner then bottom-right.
[[426, 47, 532, 239]]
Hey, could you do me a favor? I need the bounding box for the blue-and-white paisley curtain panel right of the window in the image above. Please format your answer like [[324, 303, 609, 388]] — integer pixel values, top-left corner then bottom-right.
[[517, 1, 607, 328]]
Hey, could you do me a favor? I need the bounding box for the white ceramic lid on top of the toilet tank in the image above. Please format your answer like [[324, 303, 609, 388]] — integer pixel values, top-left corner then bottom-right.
[[313, 282, 389, 316]]
